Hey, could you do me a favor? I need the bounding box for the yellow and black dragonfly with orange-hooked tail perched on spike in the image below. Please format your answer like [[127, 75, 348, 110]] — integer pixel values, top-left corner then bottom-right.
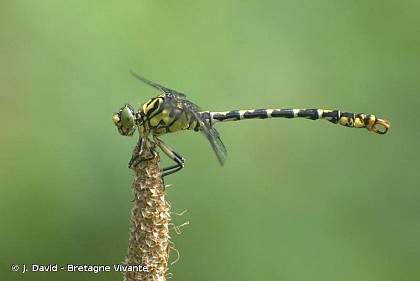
[[112, 72, 390, 177]]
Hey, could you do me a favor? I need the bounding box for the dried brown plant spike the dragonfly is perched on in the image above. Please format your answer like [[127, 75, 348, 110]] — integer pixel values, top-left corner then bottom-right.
[[124, 144, 171, 281]]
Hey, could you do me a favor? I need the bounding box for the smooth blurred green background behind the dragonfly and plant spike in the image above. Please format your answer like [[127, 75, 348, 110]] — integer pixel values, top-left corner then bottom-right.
[[0, 0, 420, 281]]
